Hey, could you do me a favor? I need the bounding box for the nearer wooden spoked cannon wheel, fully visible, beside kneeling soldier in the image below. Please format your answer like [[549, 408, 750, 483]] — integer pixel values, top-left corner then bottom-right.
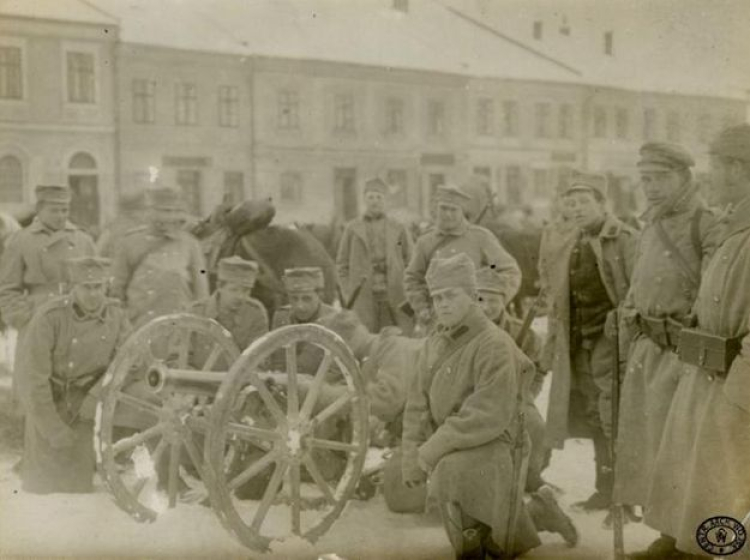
[[205, 324, 369, 550]]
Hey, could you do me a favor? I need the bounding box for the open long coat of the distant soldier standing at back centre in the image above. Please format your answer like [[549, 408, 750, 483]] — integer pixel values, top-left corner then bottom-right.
[[336, 217, 413, 332]]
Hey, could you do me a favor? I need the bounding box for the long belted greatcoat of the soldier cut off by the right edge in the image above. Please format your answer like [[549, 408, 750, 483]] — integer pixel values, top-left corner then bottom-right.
[[645, 197, 750, 554]]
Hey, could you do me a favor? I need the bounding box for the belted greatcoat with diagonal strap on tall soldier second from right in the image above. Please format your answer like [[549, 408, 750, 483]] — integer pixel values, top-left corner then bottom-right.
[[615, 191, 717, 505]]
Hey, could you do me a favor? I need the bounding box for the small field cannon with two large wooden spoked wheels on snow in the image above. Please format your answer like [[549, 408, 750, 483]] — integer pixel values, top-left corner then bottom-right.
[[95, 314, 369, 551]]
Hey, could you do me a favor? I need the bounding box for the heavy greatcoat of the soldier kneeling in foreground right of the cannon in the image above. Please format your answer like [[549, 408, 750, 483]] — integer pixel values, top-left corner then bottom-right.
[[403, 307, 539, 552]]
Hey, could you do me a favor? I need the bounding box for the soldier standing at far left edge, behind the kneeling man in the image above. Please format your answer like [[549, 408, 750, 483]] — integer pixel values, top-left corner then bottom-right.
[[0, 185, 95, 404]]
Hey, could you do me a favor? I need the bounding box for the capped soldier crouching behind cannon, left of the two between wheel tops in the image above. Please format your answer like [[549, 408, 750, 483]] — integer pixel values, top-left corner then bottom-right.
[[190, 257, 268, 352]]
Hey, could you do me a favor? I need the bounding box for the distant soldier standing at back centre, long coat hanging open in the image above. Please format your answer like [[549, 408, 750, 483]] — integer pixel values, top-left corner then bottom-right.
[[336, 178, 412, 333]]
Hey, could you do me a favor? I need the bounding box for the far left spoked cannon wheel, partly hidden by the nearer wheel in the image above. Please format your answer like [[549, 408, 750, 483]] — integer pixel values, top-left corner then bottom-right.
[[95, 314, 240, 521]]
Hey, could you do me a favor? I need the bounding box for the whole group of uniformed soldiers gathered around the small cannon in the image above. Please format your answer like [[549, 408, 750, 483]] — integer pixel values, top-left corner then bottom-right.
[[0, 125, 750, 560]]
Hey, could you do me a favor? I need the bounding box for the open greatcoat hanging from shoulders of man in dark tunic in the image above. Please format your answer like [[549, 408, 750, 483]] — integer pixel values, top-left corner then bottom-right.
[[546, 216, 636, 449]]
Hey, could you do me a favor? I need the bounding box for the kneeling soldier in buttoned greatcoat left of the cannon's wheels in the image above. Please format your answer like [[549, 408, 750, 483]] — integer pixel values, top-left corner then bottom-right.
[[18, 257, 129, 494]]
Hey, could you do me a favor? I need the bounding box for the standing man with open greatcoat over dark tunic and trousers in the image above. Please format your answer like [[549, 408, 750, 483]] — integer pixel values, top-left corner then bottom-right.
[[546, 173, 636, 510]]
